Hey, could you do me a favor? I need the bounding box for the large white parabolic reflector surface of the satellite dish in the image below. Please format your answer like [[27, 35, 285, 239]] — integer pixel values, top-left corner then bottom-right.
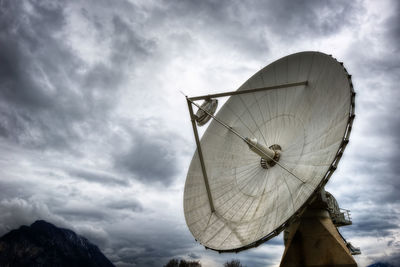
[[184, 52, 354, 251]]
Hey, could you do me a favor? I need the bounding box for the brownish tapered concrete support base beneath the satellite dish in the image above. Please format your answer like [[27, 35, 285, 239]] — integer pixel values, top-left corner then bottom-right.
[[280, 208, 357, 267]]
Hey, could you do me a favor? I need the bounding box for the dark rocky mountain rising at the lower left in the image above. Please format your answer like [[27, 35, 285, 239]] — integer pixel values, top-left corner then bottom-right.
[[0, 220, 114, 267]]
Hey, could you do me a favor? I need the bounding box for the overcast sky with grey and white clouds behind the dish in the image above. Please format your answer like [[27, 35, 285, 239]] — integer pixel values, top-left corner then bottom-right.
[[0, 0, 400, 267]]
